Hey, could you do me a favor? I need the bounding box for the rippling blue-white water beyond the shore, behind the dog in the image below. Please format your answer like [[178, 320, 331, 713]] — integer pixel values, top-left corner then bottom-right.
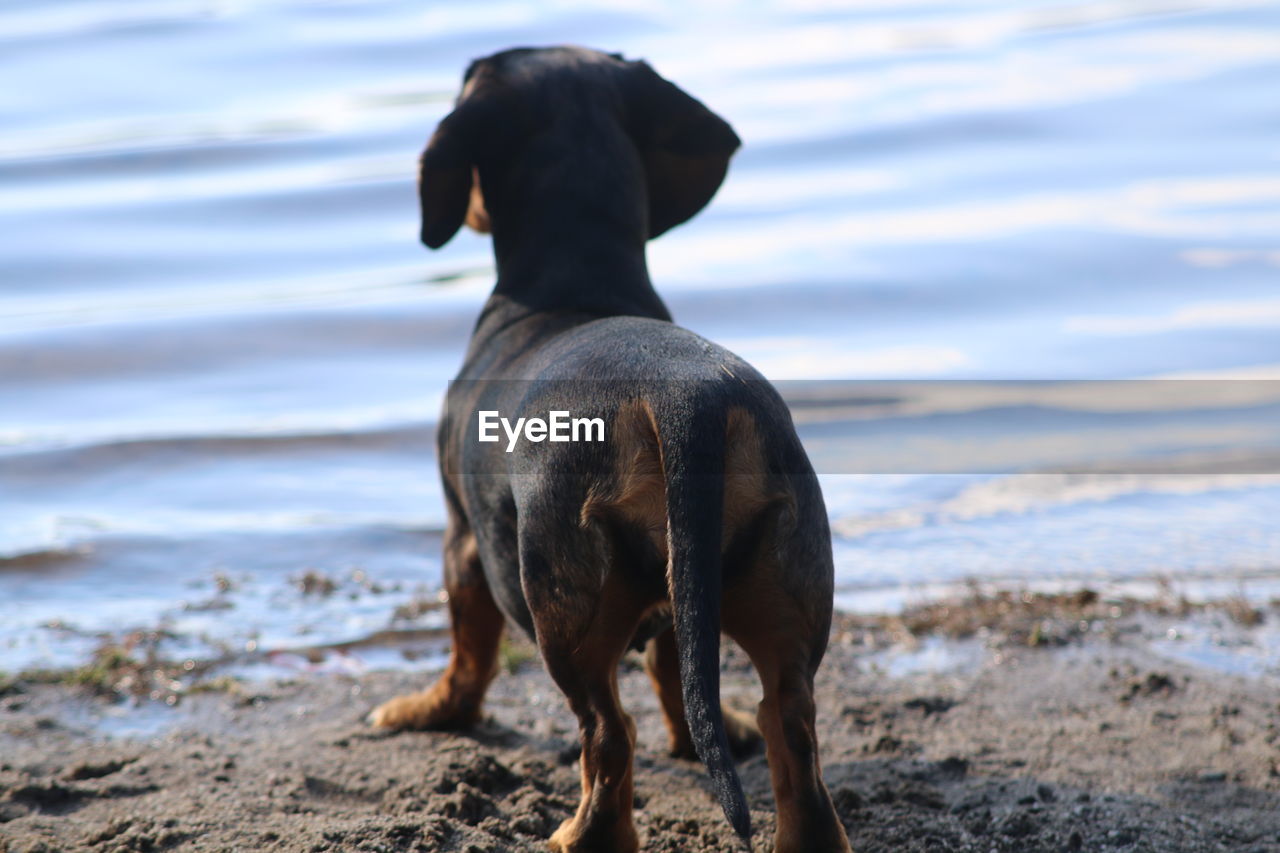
[[0, 0, 1280, 670]]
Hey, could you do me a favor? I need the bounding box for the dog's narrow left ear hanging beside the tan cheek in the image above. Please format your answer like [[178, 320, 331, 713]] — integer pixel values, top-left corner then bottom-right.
[[417, 101, 484, 248]]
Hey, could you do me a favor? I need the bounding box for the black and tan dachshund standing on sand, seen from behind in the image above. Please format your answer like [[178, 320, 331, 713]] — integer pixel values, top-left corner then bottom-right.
[[370, 47, 850, 853]]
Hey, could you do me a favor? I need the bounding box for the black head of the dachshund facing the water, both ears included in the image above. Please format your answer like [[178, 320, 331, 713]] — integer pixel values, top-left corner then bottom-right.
[[419, 47, 740, 248]]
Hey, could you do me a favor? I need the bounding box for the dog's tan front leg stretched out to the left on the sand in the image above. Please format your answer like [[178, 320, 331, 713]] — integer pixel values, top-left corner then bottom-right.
[[370, 520, 504, 729]]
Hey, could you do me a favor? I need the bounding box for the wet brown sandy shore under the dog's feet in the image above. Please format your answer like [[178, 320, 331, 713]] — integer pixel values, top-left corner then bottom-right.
[[0, 596, 1280, 853]]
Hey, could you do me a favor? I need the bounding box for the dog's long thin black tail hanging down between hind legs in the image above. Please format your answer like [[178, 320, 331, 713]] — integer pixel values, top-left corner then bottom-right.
[[654, 401, 751, 849]]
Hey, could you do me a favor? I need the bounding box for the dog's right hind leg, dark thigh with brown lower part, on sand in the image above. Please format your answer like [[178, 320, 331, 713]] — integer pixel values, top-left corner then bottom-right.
[[723, 555, 850, 853]]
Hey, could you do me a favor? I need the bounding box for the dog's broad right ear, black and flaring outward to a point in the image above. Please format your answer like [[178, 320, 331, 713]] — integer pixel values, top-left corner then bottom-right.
[[625, 61, 741, 238]]
